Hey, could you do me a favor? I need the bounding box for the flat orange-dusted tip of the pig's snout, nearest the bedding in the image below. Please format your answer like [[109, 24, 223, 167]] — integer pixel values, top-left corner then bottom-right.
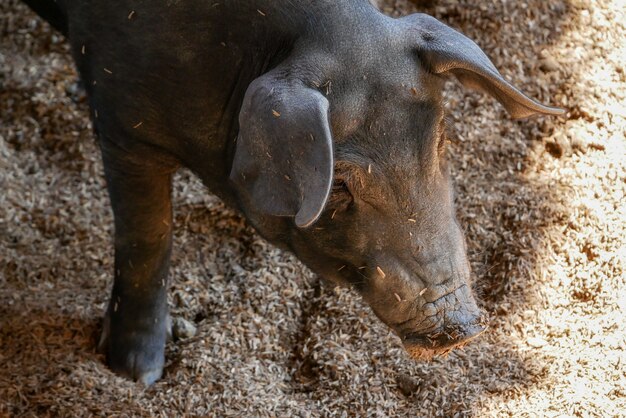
[[402, 316, 488, 358]]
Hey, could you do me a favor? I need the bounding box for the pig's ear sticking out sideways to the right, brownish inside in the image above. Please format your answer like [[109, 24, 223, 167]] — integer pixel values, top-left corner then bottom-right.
[[405, 14, 564, 118]]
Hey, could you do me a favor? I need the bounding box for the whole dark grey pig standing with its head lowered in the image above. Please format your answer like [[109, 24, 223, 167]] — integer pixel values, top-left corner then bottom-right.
[[27, 0, 561, 384]]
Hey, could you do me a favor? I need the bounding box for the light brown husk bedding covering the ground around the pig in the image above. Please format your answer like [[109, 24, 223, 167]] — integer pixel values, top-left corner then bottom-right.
[[0, 0, 626, 417]]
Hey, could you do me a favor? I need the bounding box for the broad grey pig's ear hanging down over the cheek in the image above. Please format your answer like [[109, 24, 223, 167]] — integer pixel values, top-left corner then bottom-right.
[[230, 73, 333, 228]]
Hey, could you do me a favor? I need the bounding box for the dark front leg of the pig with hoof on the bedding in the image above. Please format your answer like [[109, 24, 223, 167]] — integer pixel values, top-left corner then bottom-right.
[[99, 144, 173, 385]]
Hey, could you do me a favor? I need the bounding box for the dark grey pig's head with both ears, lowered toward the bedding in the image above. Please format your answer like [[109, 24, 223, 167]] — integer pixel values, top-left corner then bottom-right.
[[231, 15, 561, 356]]
